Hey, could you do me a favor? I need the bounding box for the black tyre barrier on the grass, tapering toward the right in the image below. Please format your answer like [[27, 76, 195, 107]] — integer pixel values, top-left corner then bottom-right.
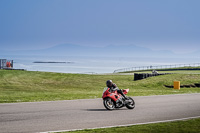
[[134, 73, 172, 81]]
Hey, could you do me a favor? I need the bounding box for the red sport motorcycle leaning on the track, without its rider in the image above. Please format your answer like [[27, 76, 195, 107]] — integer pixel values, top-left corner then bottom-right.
[[102, 88, 135, 110]]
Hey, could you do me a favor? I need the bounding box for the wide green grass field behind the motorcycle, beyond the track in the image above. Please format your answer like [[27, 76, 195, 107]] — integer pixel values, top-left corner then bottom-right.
[[0, 70, 200, 103]]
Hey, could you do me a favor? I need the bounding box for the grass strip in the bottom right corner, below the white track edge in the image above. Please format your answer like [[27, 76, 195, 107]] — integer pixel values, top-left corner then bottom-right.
[[65, 119, 200, 133]]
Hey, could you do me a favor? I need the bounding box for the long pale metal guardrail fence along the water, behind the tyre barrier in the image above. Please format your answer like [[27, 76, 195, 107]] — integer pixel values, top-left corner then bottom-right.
[[113, 63, 200, 73]]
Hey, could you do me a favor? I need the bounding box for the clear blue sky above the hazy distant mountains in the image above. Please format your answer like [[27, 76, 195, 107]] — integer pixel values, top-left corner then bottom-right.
[[0, 0, 200, 53]]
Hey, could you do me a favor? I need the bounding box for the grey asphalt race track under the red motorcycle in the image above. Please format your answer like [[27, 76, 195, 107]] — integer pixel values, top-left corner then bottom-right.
[[0, 94, 200, 133]]
